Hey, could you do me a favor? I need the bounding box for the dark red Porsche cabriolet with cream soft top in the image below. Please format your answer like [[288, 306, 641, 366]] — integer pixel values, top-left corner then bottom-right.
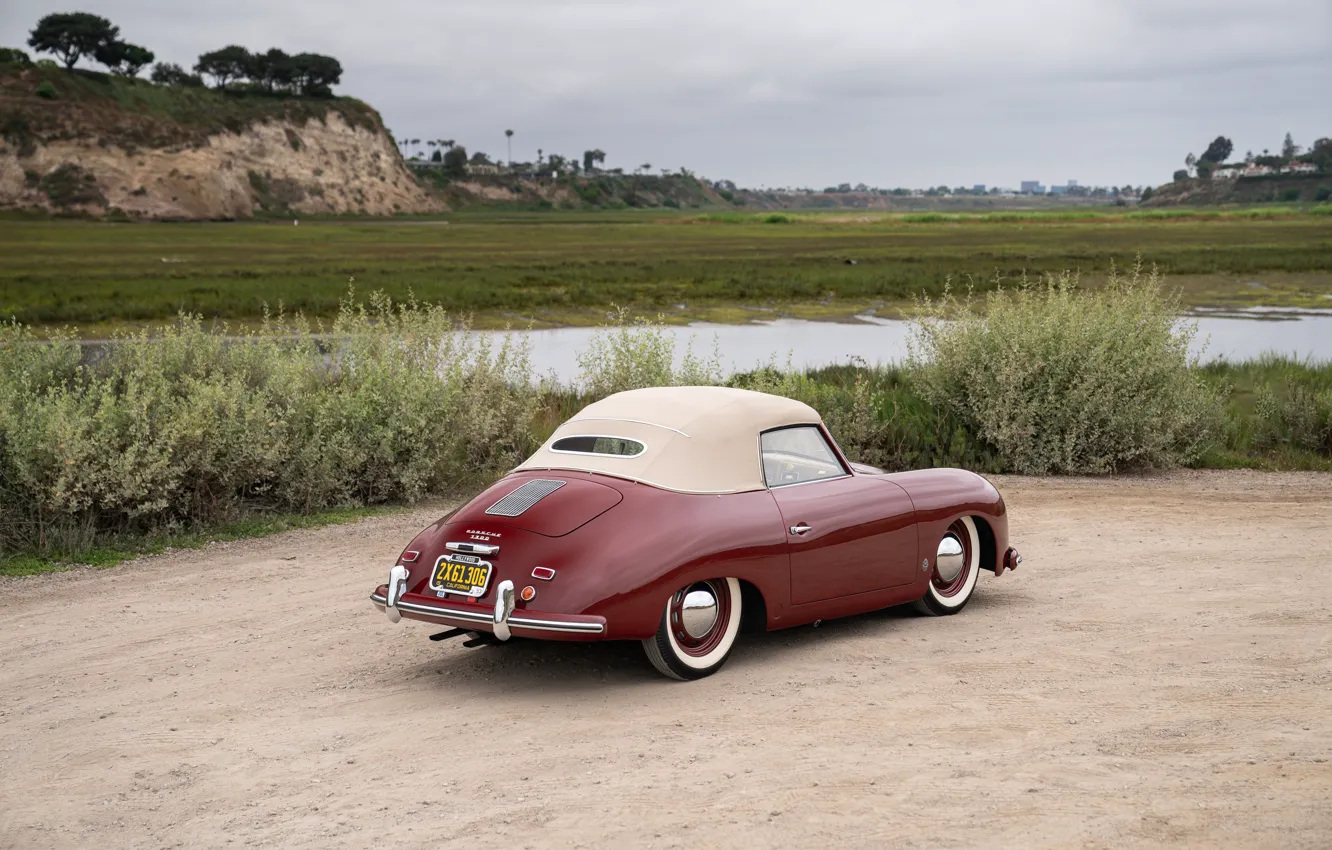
[[370, 386, 1022, 679]]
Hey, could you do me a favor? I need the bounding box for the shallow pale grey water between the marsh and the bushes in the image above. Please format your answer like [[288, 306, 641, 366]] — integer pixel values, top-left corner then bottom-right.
[[488, 308, 1332, 382]]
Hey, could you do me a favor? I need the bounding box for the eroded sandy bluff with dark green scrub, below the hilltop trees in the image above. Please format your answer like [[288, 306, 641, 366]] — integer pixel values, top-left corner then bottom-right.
[[0, 65, 442, 218]]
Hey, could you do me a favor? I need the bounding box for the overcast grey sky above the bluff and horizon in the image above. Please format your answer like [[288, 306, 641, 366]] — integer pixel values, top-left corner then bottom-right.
[[0, 0, 1332, 188]]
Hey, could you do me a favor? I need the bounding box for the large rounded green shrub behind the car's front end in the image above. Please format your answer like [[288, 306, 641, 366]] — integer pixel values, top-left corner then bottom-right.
[[908, 268, 1221, 474]]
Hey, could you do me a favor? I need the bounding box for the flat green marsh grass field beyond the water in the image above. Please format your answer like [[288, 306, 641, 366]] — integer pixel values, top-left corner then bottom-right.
[[0, 207, 1332, 336]]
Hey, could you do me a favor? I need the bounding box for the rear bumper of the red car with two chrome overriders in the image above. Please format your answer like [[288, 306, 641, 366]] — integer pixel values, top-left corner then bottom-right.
[[370, 566, 606, 641]]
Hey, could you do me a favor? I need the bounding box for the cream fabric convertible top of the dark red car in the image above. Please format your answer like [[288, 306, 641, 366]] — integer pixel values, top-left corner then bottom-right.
[[518, 386, 821, 493]]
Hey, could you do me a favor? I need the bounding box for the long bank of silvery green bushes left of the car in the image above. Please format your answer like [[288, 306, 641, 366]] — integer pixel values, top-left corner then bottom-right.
[[0, 296, 537, 553]]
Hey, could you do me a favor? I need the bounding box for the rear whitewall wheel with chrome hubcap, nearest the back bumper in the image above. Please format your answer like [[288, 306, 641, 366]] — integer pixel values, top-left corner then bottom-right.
[[643, 578, 741, 679]]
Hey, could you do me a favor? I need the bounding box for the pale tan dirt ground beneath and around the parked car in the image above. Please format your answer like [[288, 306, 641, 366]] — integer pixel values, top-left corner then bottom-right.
[[0, 473, 1332, 849]]
